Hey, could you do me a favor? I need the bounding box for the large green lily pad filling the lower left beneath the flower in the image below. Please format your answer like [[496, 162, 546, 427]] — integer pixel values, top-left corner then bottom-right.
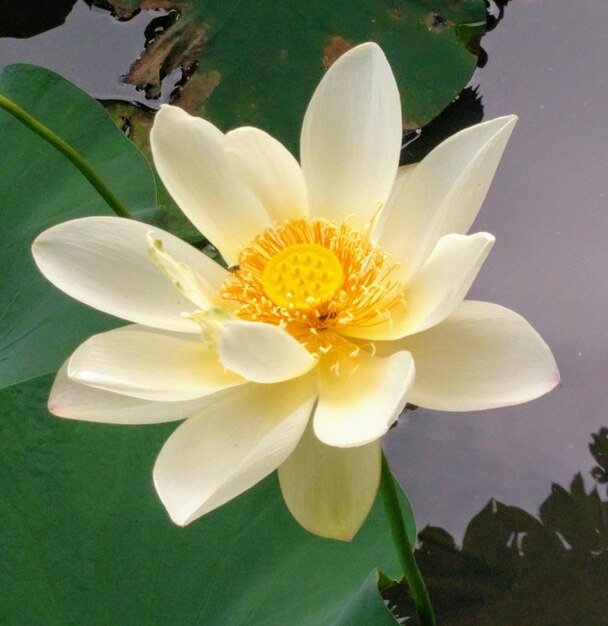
[[0, 376, 415, 626]]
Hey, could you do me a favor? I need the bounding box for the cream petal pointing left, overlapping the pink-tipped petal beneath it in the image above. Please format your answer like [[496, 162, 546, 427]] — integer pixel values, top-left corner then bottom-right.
[[68, 327, 245, 402]]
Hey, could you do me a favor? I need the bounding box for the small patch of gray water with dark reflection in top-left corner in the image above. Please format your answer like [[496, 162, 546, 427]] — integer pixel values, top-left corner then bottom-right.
[[0, 0, 176, 109]]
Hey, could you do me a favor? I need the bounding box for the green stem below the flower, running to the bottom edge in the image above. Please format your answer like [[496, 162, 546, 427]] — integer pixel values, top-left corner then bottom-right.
[[380, 452, 436, 626]]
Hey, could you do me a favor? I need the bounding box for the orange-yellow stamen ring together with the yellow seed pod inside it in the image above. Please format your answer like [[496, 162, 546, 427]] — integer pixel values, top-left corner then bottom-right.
[[221, 219, 403, 363]]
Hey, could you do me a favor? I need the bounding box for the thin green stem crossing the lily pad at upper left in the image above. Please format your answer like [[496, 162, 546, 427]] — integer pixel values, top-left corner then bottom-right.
[[0, 95, 133, 218]]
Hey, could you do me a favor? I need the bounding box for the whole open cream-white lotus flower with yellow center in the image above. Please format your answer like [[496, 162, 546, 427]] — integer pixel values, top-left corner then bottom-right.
[[33, 43, 559, 540]]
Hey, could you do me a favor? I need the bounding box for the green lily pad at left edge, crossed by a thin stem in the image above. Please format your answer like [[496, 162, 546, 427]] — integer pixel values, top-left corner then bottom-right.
[[0, 65, 157, 388]]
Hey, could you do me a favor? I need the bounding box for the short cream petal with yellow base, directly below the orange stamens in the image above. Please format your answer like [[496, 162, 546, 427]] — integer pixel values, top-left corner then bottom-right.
[[314, 352, 414, 447]]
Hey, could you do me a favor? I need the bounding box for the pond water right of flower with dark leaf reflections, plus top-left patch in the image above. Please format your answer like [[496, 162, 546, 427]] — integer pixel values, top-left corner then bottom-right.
[[0, 0, 608, 625]]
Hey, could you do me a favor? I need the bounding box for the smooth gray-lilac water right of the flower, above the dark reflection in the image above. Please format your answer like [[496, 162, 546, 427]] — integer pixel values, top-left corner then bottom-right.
[[387, 0, 608, 536]]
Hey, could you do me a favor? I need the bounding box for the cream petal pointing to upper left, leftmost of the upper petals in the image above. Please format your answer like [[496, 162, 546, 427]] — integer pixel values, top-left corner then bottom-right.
[[150, 105, 270, 262]]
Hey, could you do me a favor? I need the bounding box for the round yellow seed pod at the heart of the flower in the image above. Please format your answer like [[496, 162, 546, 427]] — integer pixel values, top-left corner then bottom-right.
[[262, 243, 344, 309]]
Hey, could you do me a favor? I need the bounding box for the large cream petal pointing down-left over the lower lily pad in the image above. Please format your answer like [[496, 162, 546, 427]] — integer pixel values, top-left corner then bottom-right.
[[154, 376, 315, 526]]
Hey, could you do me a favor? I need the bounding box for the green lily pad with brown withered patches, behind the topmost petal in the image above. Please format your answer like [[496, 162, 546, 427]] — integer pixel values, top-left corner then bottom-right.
[[104, 0, 486, 153]]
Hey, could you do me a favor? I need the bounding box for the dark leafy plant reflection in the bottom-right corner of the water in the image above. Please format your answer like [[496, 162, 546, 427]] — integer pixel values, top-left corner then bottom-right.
[[383, 428, 608, 626]]
